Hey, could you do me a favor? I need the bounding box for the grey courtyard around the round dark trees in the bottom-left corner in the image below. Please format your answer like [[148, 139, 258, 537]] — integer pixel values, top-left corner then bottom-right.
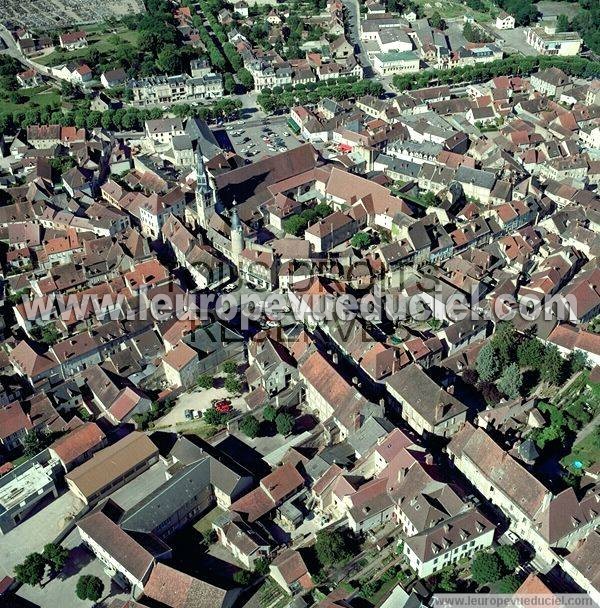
[[17, 530, 129, 608]]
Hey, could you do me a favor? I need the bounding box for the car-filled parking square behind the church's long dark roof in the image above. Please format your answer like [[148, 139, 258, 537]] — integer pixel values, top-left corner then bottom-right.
[[225, 116, 300, 160]]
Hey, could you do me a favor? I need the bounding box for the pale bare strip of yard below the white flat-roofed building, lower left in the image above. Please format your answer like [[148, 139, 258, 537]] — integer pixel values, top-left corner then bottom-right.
[[0, 491, 84, 580]]
